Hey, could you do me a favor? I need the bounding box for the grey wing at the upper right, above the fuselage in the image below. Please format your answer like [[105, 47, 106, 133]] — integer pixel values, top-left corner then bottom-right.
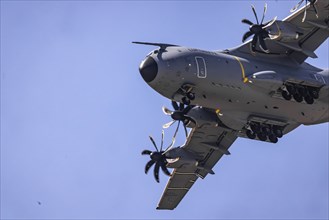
[[236, 0, 329, 63]]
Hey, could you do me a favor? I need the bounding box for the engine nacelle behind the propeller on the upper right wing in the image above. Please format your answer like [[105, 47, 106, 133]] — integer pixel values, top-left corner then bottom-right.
[[266, 21, 303, 42]]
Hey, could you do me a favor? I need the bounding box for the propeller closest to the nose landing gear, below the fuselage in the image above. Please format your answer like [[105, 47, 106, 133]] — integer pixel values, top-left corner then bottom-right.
[[162, 101, 196, 138]]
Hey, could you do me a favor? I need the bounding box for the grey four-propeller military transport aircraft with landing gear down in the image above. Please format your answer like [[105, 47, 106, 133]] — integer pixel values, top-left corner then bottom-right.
[[133, 0, 329, 209]]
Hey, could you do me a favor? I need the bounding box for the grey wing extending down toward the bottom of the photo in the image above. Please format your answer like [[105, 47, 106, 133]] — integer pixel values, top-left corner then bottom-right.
[[157, 110, 237, 210]]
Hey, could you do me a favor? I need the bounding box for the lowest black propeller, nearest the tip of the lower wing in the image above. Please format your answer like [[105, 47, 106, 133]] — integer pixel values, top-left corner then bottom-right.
[[142, 131, 175, 183]]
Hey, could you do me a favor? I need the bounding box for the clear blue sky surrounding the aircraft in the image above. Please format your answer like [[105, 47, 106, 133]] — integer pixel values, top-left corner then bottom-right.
[[0, 0, 329, 219]]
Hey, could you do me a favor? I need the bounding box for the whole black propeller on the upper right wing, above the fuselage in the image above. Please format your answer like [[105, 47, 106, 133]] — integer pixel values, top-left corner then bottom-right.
[[241, 4, 277, 53]]
